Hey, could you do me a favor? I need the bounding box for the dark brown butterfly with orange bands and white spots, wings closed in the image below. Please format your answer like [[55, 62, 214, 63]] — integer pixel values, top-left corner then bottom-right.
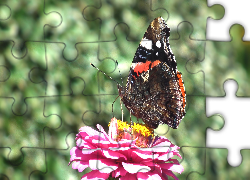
[[118, 17, 186, 129]]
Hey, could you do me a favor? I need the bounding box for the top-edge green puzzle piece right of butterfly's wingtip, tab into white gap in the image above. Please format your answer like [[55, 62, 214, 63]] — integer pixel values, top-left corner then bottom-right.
[[152, 0, 224, 40]]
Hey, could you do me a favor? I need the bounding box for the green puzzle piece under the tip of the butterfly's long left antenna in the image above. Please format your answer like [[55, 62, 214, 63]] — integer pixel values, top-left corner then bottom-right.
[[45, 43, 118, 96]]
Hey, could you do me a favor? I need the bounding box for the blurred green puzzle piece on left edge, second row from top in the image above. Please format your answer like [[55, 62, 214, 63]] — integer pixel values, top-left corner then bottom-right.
[[0, 41, 46, 115]]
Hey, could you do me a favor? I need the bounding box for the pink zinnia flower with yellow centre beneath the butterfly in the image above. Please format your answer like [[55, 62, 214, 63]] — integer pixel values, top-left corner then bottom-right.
[[70, 118, 184, 180]]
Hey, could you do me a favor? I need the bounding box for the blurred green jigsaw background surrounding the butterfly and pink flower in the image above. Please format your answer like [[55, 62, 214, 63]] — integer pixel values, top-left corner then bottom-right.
[[0, 0, 250, 180]]
